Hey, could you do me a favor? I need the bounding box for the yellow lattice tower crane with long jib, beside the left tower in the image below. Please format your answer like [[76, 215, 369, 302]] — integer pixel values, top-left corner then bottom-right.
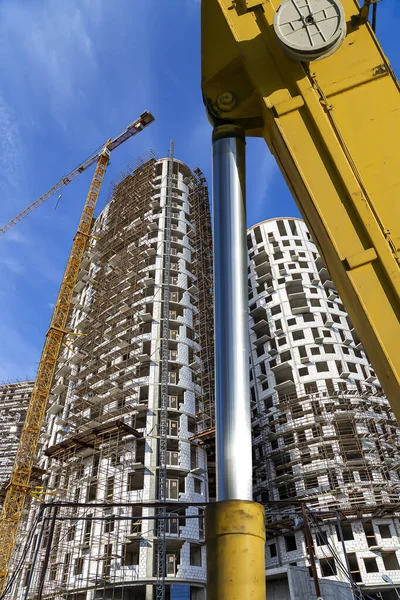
[[0, 112, 154, 592]]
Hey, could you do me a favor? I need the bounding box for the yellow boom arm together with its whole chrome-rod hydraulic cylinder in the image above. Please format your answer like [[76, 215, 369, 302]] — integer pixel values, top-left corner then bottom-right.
[[201, 0, 400, 600]]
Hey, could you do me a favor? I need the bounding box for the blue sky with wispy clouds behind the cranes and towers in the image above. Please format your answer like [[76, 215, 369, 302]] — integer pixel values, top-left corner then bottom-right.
[[0, 0, 400, 381]]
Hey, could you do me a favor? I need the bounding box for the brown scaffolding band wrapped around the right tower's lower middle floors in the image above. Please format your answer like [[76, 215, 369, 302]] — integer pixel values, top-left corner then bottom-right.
[[254, 380, 400, 514]]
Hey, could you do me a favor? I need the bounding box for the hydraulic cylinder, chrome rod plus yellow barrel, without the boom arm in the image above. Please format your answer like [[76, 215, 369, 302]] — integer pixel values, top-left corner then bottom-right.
[[206, 125, 265, 600]]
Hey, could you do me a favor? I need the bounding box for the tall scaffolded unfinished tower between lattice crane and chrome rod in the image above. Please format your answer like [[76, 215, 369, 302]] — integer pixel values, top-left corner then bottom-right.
[[6, 154, 214, 600]]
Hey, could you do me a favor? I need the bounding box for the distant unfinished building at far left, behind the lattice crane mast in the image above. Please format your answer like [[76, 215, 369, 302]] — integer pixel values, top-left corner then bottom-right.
[[0, 381, 34, 502]]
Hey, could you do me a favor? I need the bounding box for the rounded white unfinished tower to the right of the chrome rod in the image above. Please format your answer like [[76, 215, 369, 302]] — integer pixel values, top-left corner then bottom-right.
[[247, 218, 400, 600]]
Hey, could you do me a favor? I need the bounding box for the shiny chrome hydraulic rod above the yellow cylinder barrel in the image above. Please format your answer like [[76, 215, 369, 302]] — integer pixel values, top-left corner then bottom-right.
[[213, 125, 253, 500]]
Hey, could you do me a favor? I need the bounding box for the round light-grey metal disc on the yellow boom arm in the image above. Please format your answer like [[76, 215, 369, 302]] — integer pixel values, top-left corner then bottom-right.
[[274, 0, 346, 61]]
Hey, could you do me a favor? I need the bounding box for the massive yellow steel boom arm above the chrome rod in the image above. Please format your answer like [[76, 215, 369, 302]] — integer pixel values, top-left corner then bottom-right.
[[202, 0, 400, 419]]
